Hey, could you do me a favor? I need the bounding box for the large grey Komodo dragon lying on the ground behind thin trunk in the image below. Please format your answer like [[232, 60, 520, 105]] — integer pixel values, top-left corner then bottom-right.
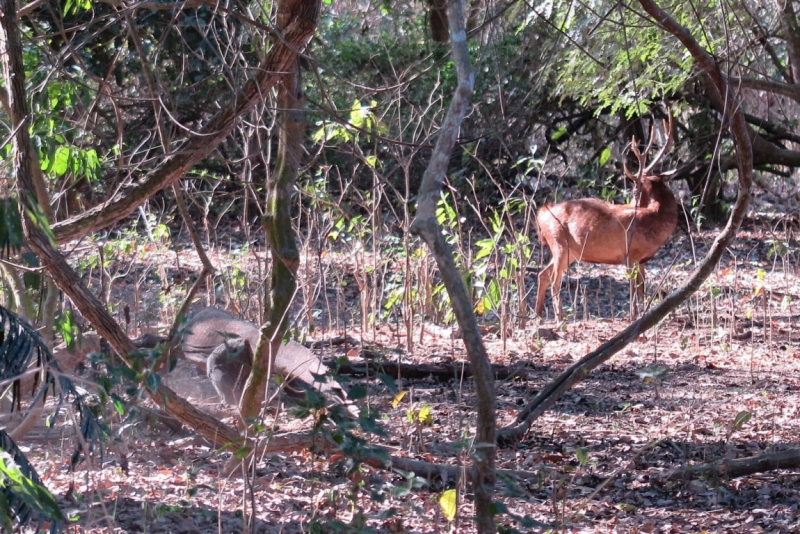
[[175, 308, 352, 413]]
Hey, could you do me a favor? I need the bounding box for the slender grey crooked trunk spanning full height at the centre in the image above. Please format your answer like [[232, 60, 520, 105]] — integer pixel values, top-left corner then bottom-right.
[[410, 0, 496, 533]]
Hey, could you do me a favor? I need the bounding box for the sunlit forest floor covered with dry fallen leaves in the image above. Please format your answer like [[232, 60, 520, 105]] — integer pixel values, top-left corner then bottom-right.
[[22, 215, 800, 534]]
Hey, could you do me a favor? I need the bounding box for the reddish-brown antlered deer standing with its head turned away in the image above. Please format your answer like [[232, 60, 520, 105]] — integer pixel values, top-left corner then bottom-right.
[[536, 117, 678, 319]]
